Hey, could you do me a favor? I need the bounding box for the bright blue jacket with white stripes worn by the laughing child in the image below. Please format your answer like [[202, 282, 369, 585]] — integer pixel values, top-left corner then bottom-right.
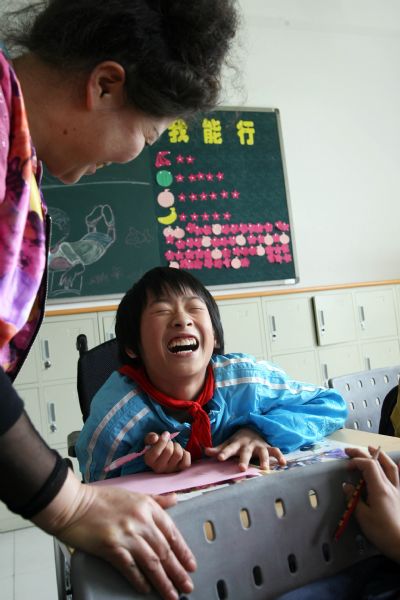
[[76, 354, 347, 481]]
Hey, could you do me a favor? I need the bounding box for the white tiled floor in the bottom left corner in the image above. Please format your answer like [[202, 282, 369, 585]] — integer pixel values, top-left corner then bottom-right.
[[0, 527, 57, 600]]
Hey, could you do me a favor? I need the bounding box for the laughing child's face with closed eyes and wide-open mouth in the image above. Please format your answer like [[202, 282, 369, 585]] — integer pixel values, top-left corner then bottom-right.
[[140, 290, 215, 399]]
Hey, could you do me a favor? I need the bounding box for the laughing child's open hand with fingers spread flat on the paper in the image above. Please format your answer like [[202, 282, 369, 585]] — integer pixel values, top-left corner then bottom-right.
[[205, 427, 286, 471]]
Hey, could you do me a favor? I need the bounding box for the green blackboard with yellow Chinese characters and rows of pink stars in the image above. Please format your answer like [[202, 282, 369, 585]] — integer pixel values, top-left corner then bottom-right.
[[43, 109, 297, 299]]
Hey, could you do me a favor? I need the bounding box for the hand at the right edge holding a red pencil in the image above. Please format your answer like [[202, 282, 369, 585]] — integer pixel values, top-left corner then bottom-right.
[[344, 447, 400, 562]]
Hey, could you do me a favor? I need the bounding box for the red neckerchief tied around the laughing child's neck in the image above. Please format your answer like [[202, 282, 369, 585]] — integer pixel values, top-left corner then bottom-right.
[[119, 365, 214, 460]]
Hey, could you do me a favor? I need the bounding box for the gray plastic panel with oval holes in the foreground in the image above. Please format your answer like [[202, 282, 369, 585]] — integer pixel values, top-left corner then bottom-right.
[[62, 452, 400, 600]]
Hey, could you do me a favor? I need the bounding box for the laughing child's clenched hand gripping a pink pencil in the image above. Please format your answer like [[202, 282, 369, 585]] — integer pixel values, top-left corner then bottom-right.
[[144, 431, 191, 473]]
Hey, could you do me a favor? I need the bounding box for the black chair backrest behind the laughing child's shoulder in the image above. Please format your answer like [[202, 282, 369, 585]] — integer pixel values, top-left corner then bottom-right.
[[76, 334, 120, 421]]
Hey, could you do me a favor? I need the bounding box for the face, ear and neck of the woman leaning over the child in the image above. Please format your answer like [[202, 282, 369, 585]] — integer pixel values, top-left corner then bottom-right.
[[32, 61, 173, 183]]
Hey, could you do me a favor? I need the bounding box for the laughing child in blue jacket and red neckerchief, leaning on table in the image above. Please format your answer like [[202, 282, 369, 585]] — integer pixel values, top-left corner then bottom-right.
[[76, 267, 347, 481]]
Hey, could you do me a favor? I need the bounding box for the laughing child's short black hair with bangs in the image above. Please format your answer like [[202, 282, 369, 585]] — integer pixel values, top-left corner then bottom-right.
[[115, 267, 224, 364]]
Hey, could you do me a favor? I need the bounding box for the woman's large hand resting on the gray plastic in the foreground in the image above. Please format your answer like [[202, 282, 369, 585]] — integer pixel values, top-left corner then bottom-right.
[[33, 472, 196, 600]]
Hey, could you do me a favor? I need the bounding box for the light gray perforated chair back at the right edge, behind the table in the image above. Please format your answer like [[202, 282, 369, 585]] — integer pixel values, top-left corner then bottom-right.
[[328, 366, 400, 433]]
